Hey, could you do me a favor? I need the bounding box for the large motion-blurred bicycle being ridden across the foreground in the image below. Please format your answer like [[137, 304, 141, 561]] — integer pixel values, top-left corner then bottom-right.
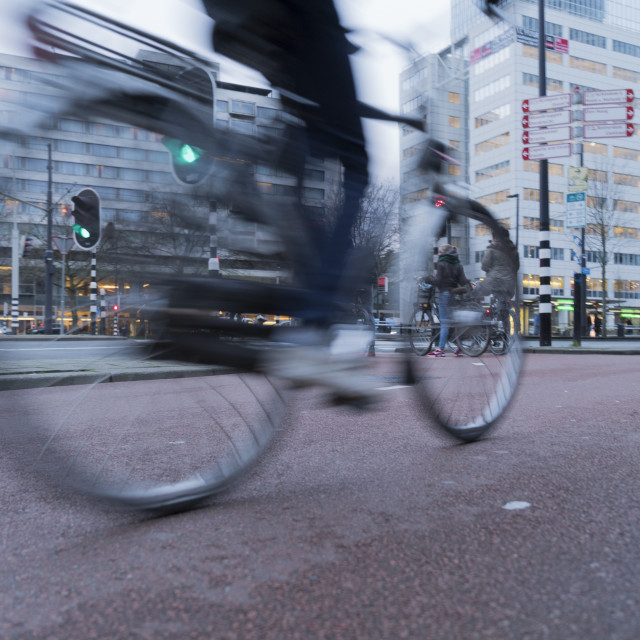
[[0, 0, 521, 512]]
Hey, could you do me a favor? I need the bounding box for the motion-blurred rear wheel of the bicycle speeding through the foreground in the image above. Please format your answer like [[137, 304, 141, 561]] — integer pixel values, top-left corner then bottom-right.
[[0, 87, 304, 511]]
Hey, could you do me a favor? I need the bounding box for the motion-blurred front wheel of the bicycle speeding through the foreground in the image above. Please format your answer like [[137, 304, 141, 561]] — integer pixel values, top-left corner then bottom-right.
[[403, 185, 522, 442]]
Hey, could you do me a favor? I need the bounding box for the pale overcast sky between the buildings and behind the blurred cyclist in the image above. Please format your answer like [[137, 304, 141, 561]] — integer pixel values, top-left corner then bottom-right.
[[0, 0, 450, 181]]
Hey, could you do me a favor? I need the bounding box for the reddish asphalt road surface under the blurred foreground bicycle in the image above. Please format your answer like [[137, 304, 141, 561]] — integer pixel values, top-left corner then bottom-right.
[[0, 354, 640, 640]]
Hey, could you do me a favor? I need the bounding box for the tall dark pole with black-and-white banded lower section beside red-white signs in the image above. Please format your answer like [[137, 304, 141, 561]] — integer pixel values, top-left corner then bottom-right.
[[538, 0, 551, 347]]
